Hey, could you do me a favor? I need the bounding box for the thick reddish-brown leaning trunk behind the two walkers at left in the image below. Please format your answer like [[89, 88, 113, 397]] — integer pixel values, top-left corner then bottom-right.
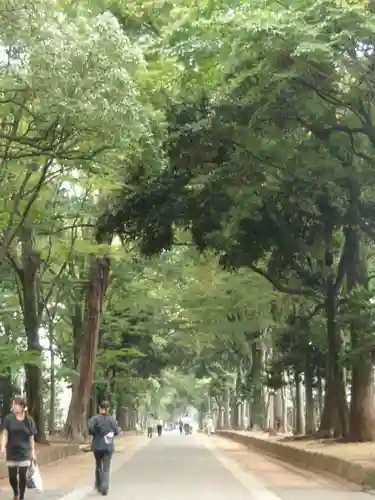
[[65, 257, 109, 439]]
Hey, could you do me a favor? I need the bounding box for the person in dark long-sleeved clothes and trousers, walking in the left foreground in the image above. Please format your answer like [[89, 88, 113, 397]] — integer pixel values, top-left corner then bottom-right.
[[87, 401, 120, 495]]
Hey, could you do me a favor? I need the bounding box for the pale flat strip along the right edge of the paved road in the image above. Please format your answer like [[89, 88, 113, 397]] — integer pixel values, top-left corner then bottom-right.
[[203, 438, 281, 500]]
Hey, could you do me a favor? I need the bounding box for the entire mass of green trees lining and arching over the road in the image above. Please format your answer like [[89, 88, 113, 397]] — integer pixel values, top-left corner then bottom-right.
[[0, 0, 375, 441]]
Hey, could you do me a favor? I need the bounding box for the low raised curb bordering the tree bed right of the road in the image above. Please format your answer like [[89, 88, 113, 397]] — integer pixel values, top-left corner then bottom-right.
[[216, 430, 375, 490]]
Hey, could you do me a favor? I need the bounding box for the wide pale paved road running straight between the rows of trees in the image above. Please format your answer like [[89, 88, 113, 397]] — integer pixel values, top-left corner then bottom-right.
[[52, 434, 374, 500]]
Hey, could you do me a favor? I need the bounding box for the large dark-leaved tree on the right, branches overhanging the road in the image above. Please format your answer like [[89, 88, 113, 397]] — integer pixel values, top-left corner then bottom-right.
[[105, 1, 374, 440]]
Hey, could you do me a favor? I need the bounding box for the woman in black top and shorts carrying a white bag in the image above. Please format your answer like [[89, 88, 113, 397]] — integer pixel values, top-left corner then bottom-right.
[[0, 396, 37, 500]]
